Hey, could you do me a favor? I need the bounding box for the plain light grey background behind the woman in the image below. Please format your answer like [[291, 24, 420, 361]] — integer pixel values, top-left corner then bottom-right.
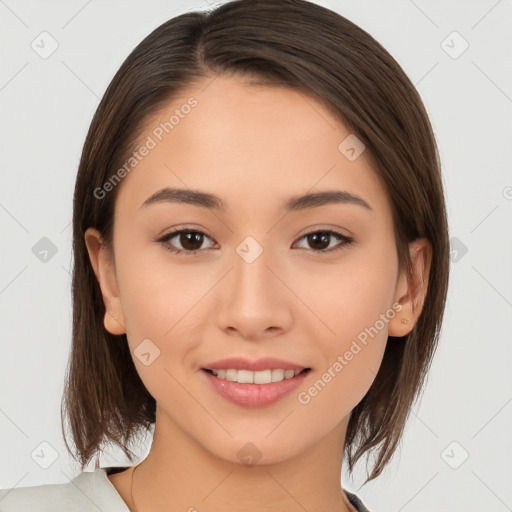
[[0, 0, 512, 512]]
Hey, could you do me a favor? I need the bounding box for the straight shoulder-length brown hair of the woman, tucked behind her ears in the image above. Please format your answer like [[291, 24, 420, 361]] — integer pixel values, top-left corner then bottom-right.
[[61, 0, 449, 481]]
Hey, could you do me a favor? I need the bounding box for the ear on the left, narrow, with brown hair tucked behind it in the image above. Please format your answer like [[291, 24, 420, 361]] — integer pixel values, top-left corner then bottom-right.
[[85, 228, 126, 335]]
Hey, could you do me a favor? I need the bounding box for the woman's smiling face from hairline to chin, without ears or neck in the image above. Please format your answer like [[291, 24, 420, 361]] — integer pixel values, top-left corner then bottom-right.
[[86, 76, 410, 463]]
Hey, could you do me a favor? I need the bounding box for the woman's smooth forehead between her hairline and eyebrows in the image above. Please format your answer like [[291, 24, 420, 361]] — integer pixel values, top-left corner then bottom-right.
[[118, 76, 386, 216]]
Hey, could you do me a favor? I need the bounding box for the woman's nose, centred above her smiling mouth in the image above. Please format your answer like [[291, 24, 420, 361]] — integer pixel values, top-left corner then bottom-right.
[[216, 242, 293, 341]]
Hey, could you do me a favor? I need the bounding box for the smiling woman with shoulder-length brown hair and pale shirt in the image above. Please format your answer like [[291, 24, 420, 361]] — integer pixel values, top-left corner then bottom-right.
[[0, 0, 449, 511]]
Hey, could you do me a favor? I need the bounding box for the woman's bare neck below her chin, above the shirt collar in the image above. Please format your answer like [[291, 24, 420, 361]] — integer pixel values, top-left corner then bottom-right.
[[128, 408, 355, 512]]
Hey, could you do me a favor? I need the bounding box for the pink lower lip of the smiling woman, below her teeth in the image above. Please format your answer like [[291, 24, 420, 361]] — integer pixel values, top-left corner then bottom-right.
[[201, 370, 311, 407]]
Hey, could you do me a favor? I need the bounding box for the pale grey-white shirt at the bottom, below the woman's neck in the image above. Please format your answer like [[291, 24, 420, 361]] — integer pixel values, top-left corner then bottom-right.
[[0, 467, 370, 512]]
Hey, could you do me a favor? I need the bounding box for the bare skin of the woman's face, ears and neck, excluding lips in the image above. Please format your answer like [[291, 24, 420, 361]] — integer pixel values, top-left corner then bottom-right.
[[85, 76, 431, 512]]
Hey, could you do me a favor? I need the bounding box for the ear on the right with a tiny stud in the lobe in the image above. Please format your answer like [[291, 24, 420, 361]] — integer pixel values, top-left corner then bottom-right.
[[388, 238, 432, 337]]
